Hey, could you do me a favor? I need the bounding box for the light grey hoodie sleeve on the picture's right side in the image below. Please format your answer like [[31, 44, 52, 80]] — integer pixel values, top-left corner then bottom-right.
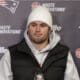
[[64, 52, 80, 80]]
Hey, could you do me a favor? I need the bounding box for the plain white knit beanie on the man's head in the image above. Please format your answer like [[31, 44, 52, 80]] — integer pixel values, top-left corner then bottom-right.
[[27, 6, 52, 29]]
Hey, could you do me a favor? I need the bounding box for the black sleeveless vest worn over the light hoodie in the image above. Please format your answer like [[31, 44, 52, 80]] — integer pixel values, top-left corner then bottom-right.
[[9, 40, 69, 80]]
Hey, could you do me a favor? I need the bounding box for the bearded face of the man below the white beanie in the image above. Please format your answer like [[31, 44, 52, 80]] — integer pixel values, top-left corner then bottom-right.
[[28, 21, 50, 44]]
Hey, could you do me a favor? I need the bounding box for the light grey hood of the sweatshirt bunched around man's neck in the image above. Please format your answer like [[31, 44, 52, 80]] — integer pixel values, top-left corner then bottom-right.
[[24, 25, 60, 53]]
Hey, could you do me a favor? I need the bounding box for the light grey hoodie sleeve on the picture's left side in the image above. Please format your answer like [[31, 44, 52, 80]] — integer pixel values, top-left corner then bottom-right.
[[0, 49, 12, 80]]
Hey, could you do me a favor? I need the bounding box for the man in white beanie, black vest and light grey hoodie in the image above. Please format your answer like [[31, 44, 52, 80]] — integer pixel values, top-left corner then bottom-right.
[[0, 6, 79, 80]]
